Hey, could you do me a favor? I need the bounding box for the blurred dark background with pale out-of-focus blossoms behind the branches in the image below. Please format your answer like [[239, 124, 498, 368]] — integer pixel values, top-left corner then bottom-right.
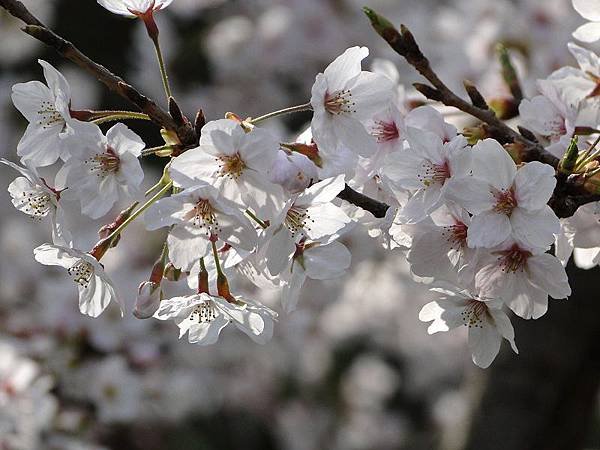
[[0, 0, 600, 450]]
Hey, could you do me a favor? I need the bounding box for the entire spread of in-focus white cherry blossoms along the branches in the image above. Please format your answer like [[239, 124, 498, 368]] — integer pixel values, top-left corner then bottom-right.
[[2, 1, 600, 384]]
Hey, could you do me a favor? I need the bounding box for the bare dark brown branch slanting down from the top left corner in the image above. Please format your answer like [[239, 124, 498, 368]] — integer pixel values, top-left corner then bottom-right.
[[0, 0, 198, 146]]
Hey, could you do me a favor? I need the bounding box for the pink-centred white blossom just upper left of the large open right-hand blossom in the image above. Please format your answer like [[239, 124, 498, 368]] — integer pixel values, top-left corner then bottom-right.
[[383, 128, 471, 223]]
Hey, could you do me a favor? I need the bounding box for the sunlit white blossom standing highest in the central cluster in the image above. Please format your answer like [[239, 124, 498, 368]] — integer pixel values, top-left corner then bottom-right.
[[310, 47, 393, 156]]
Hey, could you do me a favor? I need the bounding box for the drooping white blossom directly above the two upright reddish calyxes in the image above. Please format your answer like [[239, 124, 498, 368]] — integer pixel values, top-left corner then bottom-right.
[[145, 184, 256, 271]]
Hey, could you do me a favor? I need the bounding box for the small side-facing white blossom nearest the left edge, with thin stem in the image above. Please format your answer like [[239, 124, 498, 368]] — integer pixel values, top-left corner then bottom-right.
[[0, 158, 71, 245]]
